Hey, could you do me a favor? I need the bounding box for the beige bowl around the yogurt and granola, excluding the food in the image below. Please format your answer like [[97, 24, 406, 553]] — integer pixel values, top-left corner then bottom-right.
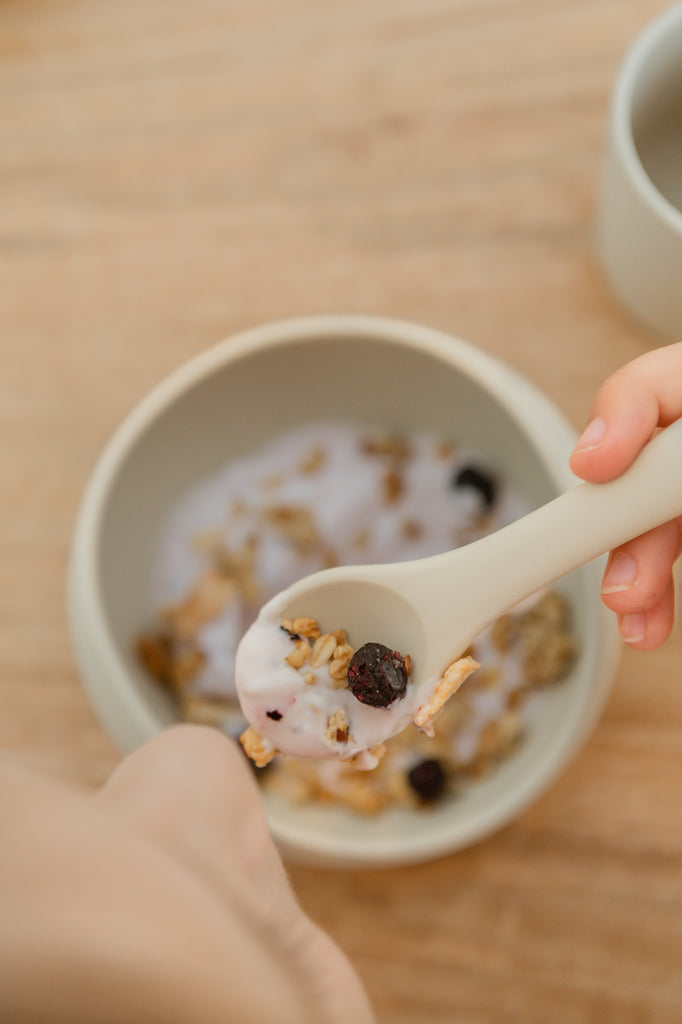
[[70, 316, 620, 866]]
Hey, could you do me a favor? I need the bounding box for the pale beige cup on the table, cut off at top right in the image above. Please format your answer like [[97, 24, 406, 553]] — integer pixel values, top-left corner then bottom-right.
[[598, 3, 682, 340]]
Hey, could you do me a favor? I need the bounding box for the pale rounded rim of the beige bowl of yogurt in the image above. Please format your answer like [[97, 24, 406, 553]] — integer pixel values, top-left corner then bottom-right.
[[68, 313, 621, 866]]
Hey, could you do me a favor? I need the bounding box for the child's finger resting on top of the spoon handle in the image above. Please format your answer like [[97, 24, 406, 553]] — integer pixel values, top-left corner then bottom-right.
[[570, 343, 682, 483]]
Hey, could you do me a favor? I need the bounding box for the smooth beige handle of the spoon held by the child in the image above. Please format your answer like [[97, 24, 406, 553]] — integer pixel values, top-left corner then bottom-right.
[[411, 420, 682, 636]]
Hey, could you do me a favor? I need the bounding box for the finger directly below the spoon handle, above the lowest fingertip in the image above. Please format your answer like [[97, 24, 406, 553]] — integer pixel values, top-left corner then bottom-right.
[[601, 521, 680, 614]]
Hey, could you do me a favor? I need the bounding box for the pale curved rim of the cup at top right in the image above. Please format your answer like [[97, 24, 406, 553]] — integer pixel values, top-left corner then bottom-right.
[[611, 3, 682, 236]]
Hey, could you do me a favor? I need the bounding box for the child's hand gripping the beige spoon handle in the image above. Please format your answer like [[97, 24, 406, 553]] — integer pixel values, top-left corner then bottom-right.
[[570, 343, 682, 650]]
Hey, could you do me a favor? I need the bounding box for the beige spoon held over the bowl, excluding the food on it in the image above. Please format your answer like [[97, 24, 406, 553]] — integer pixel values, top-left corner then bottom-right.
[[238, 420, 682, 753]]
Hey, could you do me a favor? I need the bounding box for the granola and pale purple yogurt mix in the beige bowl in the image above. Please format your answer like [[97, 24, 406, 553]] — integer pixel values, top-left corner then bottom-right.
[[138, 423, 574, 813]]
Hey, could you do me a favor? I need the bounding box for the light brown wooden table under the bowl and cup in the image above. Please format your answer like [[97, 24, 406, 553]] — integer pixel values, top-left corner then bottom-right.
[[0, 0, 682, 1024]]
